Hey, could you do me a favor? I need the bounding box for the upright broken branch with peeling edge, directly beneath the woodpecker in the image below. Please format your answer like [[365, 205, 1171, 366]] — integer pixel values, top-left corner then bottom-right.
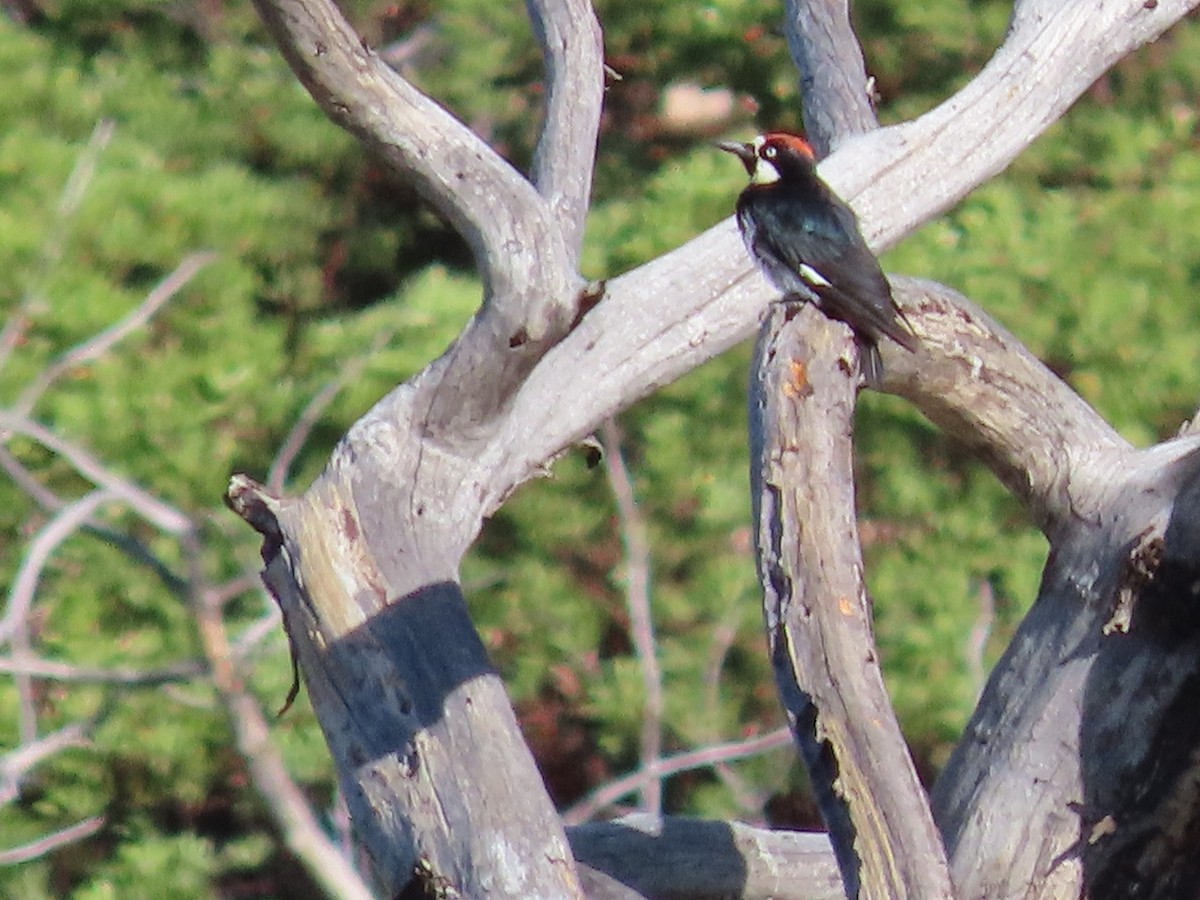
[[750, 305, 953, 900]]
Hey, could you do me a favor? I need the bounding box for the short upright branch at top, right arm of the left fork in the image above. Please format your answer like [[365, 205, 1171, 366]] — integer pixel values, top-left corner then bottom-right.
[[526, 0, 604, 266]]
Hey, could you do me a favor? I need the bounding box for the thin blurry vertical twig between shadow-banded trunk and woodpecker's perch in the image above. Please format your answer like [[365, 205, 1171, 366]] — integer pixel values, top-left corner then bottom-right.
[[600, 419, 662, 816]]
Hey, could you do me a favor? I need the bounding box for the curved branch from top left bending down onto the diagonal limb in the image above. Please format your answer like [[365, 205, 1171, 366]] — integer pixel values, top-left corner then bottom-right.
[[256, 0, 583, 443]]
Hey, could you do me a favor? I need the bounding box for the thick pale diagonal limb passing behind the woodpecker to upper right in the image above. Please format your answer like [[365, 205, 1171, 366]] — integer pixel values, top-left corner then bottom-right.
[[486, 0, 1198, 512]]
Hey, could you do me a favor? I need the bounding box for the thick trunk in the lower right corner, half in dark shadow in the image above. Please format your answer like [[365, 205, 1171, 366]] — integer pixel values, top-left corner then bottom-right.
[[934, 448, 1200, 898]]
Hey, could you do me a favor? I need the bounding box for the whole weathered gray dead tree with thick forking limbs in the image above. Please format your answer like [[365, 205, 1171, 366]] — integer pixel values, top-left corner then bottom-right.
[[229, 0, 1200, 900]]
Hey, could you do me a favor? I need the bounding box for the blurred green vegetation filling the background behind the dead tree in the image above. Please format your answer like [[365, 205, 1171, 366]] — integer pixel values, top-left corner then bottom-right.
[[0, 0, 1200, 899]]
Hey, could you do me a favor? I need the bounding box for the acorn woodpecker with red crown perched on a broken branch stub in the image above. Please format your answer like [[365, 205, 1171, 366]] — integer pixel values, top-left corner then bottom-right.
[[718, 132, 917, 388]]
